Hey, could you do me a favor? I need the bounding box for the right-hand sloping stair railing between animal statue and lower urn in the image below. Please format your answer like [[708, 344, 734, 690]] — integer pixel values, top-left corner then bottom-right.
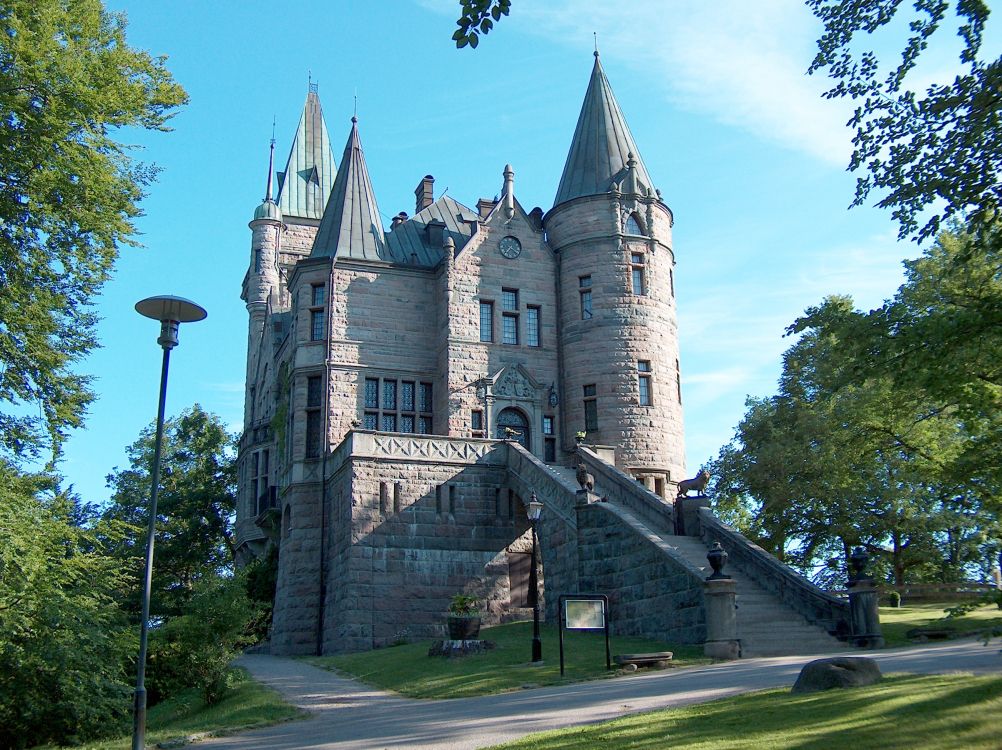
[[699, 508, 850, 636]]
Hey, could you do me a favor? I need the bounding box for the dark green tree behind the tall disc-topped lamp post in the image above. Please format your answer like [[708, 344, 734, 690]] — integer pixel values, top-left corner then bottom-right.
[[103, 404, 236, 616]]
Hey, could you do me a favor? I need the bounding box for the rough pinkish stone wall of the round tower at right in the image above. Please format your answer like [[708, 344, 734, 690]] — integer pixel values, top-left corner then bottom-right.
[[546, 193, 685, 482]]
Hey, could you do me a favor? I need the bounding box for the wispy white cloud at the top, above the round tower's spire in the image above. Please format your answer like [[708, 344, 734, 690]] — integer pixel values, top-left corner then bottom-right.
[[480, 0, 852, 166]]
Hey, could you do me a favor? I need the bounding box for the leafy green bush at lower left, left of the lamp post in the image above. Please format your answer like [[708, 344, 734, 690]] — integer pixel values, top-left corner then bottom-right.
[[0, 461, 135, 748]]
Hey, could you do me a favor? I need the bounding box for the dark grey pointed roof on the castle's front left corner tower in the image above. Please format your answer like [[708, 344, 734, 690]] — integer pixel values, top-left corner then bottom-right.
[[310, 116, 391, 260]]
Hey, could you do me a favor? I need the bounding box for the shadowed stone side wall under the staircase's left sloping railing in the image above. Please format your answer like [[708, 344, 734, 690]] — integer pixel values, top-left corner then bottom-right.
[[577, 504, 706, 644]]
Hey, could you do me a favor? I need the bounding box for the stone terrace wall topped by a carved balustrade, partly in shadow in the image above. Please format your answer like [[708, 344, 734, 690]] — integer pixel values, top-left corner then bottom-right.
[[324, 431, 528, 653]]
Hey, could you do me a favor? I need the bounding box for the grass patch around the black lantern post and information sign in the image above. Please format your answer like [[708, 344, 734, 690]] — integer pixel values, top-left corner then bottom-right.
[[309, 623, 710, 698]]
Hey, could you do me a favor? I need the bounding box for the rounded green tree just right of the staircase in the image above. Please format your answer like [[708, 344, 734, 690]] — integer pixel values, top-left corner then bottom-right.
[[713, 297, 992, 585]]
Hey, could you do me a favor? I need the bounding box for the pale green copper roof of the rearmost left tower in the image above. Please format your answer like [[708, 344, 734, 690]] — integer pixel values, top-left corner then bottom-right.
[[278, 84, 335, 219]]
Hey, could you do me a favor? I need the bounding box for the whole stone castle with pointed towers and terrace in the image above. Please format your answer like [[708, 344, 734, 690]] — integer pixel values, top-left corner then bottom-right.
[[236, 53, 853, 654]]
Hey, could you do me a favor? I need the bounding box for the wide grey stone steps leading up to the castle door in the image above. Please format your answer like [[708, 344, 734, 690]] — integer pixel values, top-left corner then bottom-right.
[[662, 536, 847, 657]]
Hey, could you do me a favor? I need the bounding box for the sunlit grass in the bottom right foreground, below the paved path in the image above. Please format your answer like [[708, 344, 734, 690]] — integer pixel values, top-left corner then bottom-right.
[[482, 675, 1002, 750]]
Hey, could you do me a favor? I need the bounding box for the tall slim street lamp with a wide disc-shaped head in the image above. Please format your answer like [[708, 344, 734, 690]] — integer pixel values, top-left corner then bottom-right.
[[132, 295, 206, 750]]
